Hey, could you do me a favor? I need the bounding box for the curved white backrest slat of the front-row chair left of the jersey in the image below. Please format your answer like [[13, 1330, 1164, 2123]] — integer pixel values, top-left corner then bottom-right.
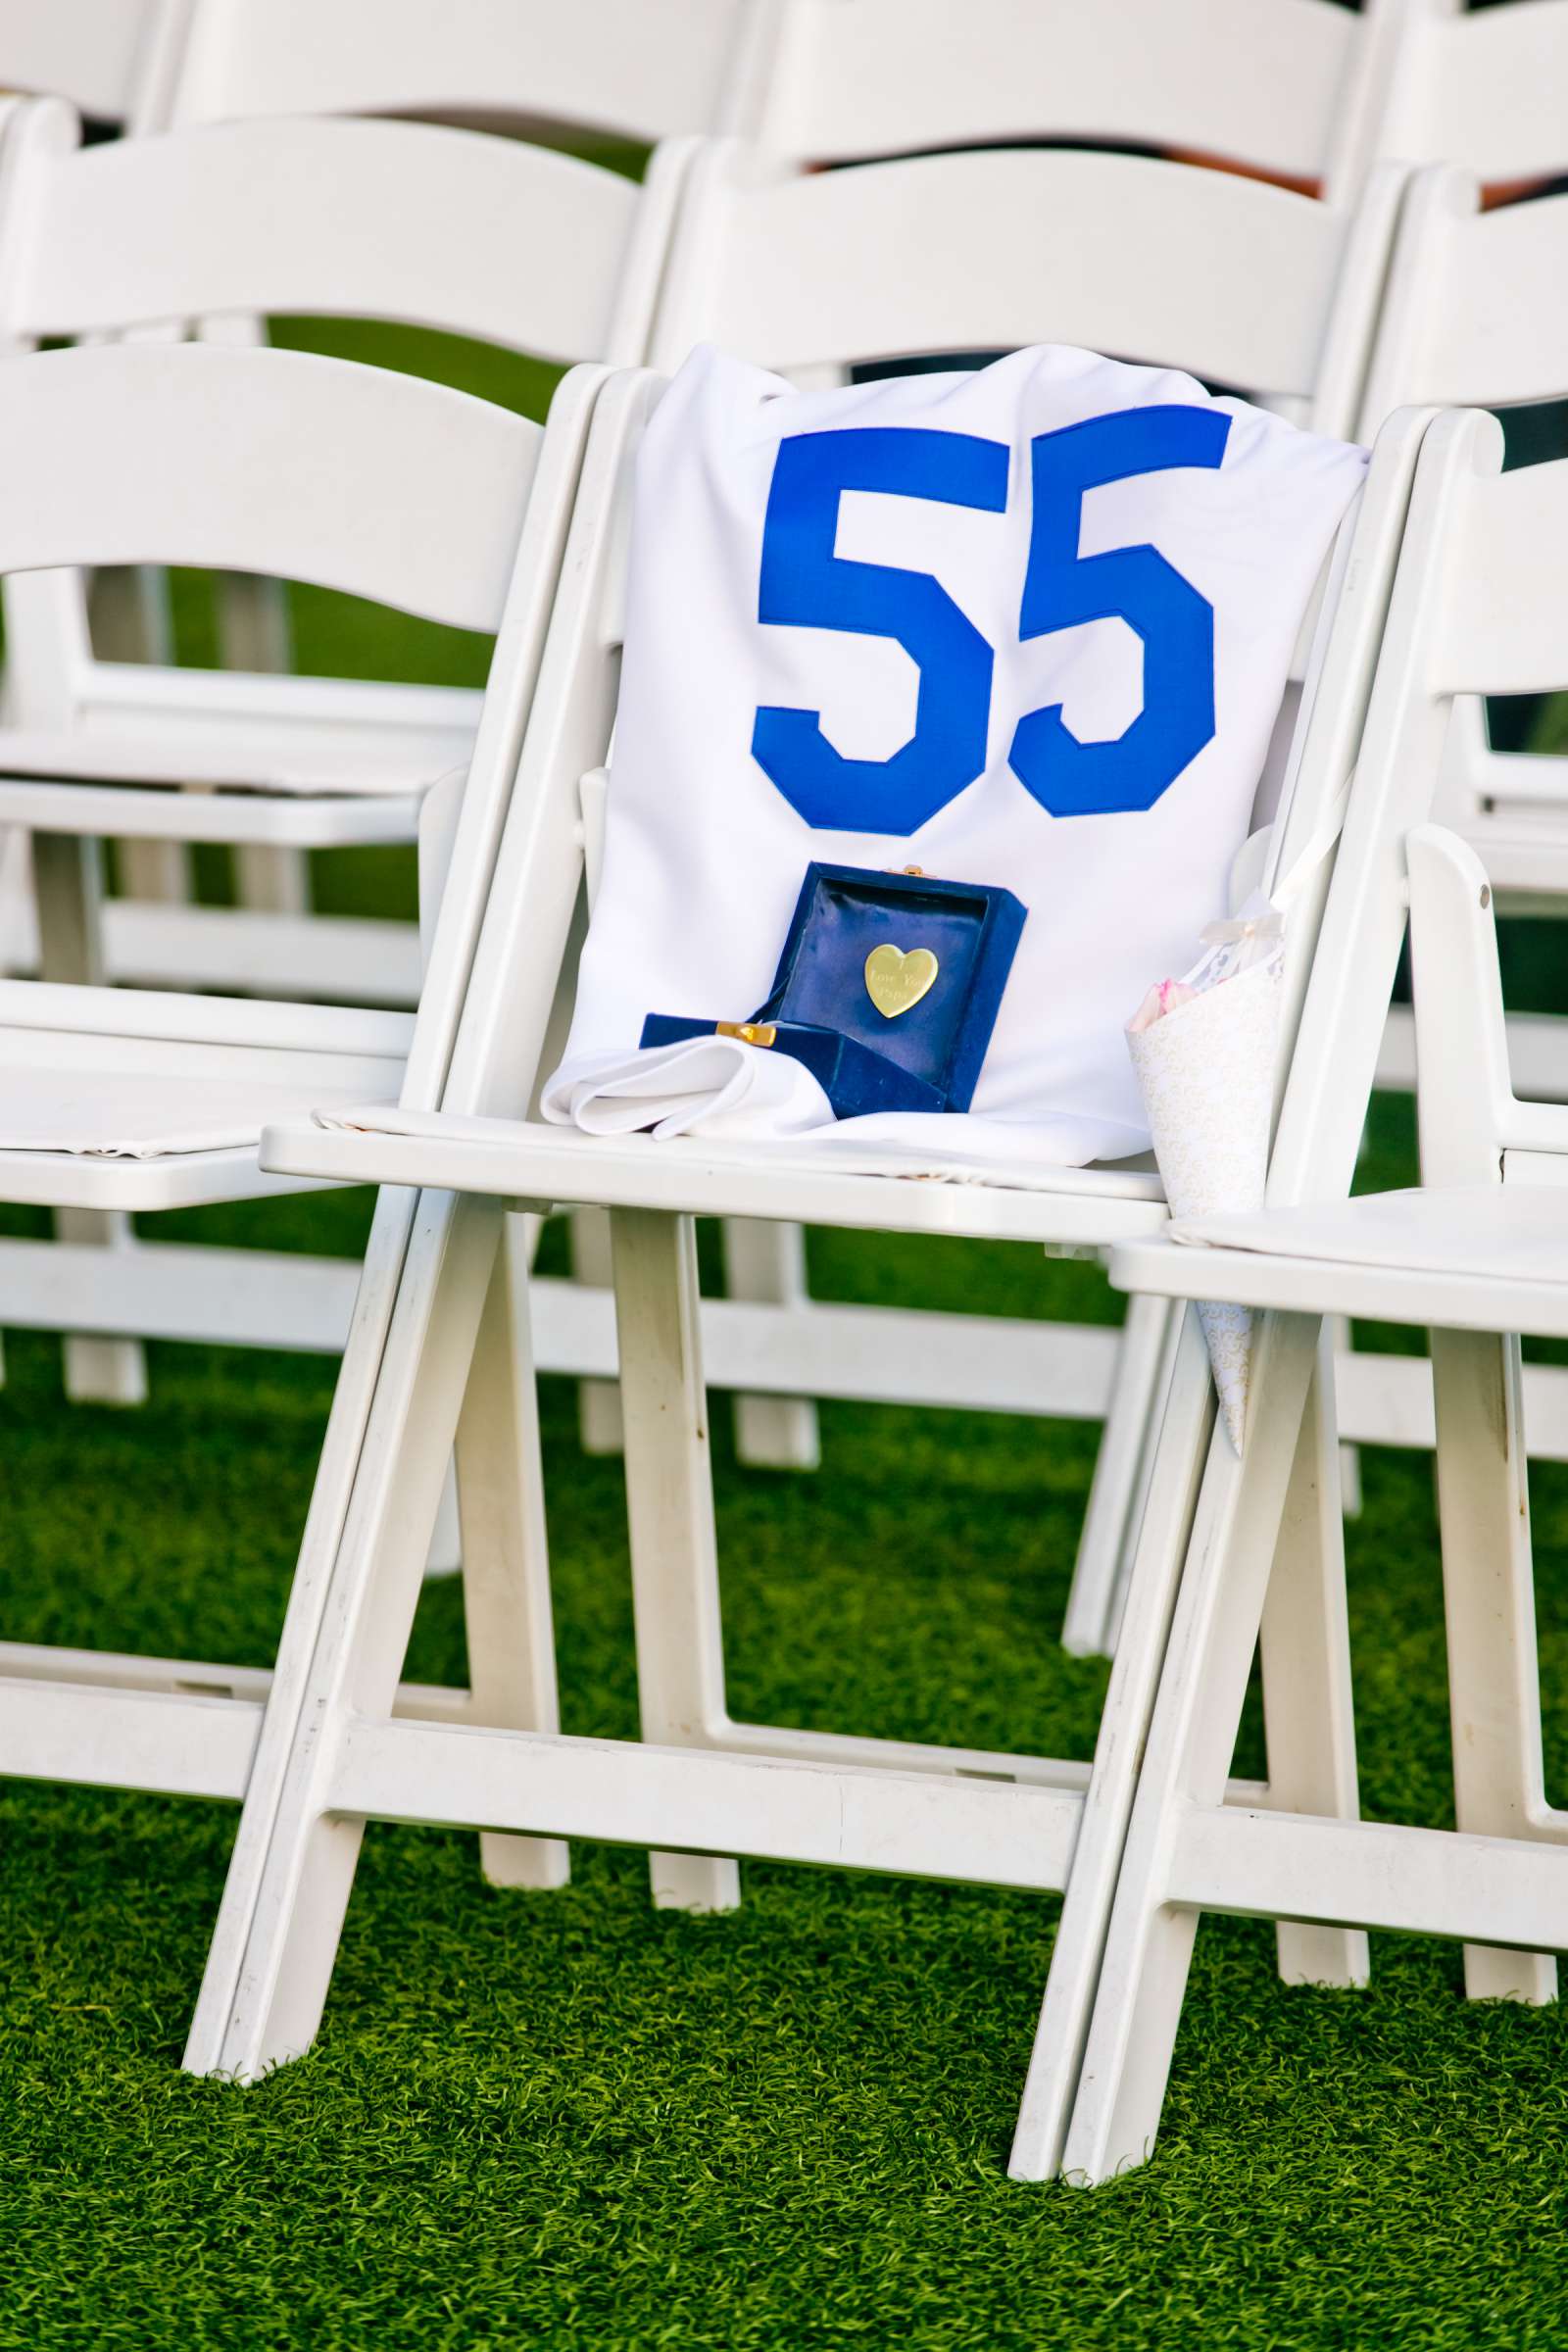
[[0, 343, 543, 630]]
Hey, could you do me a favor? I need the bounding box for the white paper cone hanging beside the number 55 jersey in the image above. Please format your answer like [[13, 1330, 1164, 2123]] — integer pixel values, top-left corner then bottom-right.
[[1126, 955, 1284, 1453]]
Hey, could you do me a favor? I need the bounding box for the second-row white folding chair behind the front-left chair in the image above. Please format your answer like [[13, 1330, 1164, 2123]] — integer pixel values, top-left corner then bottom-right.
[[0, 101, 682, 1401]]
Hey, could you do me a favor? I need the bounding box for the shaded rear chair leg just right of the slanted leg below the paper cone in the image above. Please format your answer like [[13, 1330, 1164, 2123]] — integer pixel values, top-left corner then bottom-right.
[[1260, 1331, 1371, 1987]]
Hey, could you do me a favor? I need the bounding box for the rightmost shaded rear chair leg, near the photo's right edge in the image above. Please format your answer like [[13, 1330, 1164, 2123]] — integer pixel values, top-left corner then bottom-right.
[[1432, 1331, 1556, 2001]]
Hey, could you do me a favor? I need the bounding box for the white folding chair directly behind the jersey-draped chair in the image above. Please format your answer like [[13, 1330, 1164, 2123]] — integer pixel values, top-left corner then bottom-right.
[[639, 133, 1398, 1618]]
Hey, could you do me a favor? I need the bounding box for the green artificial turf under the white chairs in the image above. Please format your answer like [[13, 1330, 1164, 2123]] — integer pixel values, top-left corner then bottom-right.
[[0, 303, 1568, 2352]]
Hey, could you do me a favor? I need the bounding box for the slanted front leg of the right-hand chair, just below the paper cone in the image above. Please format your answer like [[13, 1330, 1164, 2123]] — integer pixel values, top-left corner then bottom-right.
[[1062, 1315, 1321, 2185]]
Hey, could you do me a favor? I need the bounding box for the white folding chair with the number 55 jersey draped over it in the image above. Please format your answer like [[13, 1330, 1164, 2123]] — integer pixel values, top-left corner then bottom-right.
[[205, 348, 1425, 2129]]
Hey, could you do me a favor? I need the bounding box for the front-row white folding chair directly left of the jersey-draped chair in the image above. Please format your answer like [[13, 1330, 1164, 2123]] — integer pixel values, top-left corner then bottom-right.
[[0, 331, 602, 1884]]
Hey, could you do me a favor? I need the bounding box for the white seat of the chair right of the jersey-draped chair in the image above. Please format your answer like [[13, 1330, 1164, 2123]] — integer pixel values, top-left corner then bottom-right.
[[1109, 1186, 1568, 1339]]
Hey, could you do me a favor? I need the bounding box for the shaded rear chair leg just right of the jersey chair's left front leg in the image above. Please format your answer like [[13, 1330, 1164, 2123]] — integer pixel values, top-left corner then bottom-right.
[[456, 1216, 571, 1886]]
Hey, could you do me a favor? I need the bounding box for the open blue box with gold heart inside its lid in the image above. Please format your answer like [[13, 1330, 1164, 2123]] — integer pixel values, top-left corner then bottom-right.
[[642, 863, 1027, 1119]]
